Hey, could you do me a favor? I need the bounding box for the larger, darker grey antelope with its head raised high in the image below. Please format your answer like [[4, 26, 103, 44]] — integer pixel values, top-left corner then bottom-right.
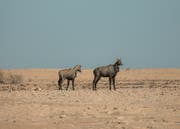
[[93, 59, 123, 90]]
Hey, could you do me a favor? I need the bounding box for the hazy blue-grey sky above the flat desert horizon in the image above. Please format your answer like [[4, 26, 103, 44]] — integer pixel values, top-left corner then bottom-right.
[[0, 0, 180, 68]]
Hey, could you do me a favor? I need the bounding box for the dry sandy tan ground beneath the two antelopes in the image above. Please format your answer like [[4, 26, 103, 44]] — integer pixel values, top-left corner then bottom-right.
[[0, 69, 180, 129]]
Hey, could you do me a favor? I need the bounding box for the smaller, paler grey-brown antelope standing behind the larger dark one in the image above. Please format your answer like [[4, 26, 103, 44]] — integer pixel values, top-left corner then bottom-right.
[[58, 65, 81, 90]]
